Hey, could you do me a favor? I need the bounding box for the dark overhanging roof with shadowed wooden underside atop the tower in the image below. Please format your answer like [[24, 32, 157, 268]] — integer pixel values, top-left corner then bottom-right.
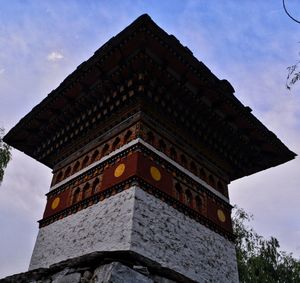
[[4, 15, 296, 180]]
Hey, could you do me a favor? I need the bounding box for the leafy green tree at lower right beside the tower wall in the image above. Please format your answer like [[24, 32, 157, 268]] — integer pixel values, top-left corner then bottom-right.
[[233, 207, 300, 283]]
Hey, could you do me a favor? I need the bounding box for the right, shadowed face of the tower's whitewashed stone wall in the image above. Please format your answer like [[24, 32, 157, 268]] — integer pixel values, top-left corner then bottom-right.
[[131, 189, 238, 283]]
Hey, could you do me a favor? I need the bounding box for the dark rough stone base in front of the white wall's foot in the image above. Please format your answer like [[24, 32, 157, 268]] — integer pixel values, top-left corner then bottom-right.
[[0, 252, 196, 283]]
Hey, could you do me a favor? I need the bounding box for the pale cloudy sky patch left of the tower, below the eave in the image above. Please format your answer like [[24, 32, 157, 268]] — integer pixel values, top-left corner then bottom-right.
[[0, 150, 51, 278]]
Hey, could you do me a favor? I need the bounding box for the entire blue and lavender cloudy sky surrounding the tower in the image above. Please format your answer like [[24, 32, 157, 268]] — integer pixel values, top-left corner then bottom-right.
[[0, 0, 300, 278]]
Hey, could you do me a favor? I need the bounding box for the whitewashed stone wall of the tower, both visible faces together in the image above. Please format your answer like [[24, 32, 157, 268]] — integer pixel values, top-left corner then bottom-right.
[[30, 187, 238, 283]]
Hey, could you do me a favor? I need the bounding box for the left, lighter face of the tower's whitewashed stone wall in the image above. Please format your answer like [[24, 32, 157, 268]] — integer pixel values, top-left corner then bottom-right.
[[29, 189, 135, 270]]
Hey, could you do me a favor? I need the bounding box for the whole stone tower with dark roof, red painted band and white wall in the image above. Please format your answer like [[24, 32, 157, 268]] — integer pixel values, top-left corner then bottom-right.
[[5, 15, 295, 283]]
